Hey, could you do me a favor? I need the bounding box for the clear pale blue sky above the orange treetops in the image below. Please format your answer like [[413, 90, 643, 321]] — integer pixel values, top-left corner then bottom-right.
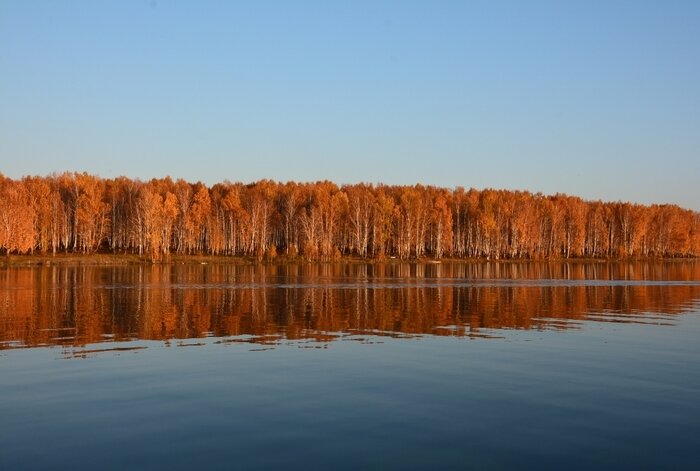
[[0, 0, 700, 210]]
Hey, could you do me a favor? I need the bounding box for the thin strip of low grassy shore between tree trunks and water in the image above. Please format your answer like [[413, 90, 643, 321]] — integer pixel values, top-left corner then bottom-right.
[[0, 253, 695, 267]]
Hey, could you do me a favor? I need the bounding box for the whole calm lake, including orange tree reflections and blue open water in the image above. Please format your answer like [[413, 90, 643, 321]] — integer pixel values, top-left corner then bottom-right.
[[0, 261, 700, 470]]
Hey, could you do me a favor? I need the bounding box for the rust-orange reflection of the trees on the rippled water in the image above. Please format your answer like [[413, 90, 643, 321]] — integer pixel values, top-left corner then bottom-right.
[[0, 262, 700, 348]]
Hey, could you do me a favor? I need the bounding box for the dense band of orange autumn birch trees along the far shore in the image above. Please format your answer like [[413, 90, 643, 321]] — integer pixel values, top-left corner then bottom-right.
[[0, 173, 700, 261]]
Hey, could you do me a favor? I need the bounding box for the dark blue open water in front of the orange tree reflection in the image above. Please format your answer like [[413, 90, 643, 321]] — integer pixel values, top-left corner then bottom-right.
[[0, 312, 700, 470]]
